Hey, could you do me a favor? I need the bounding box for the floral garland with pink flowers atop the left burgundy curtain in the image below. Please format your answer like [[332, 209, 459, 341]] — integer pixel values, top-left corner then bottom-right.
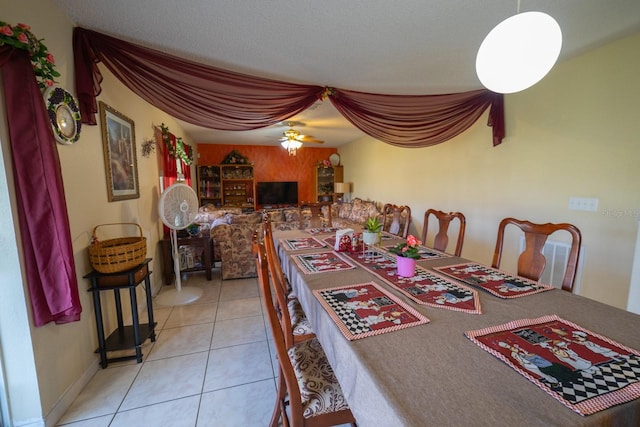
[[0, 21, 60, 90]]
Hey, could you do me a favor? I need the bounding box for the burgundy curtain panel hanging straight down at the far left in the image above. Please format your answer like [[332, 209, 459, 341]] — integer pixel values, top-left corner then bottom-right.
[[0, 46, 82, 326]]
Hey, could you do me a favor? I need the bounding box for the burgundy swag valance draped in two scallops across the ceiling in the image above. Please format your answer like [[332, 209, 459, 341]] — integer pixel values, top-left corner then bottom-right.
[[73, 28, 505, 147]]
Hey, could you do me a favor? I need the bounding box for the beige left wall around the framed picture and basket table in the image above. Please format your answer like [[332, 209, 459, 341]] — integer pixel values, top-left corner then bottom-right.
[[0, 0, 195, 425]]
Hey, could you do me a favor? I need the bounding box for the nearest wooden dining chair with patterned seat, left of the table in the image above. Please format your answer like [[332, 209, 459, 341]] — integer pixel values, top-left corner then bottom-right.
[[254, 242, 356, 427]]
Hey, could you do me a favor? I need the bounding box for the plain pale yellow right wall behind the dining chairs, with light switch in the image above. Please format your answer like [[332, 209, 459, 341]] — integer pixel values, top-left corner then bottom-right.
[[339, 30, 640, 308]]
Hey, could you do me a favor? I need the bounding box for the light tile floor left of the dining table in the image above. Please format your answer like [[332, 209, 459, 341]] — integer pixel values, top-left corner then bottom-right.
[[57, 270, 277, 427]]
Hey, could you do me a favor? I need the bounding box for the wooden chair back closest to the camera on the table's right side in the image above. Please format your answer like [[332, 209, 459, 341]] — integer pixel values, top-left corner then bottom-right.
[[491, 218, 582, 292]]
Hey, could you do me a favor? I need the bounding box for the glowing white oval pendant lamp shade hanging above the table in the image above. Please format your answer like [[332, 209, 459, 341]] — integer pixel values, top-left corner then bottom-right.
[[476, 12, 562, 93]]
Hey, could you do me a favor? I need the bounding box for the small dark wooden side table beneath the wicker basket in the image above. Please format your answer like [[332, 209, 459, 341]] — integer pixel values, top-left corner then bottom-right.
[[84, 258, 156, 368]]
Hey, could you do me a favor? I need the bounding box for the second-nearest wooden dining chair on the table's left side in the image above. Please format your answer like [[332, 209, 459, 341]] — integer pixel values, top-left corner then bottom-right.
[[262, 216, 315, 348]]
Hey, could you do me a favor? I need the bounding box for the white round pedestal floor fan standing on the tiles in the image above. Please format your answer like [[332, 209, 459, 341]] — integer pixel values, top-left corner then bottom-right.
[[157, 182, 202, 305]]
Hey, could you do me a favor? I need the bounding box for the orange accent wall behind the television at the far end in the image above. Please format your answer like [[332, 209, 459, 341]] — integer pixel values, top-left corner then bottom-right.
[[197, 144, 338, 202]]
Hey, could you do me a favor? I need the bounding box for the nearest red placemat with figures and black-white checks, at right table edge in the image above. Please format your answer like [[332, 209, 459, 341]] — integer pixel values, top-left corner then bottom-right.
[[465, 315, 640, 415]]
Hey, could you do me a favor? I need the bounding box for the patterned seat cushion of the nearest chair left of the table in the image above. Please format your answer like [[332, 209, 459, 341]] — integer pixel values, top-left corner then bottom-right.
[[288, 338, 349, 418]]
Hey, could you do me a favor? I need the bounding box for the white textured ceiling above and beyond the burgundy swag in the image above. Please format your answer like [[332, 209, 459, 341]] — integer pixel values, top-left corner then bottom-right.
[[53, 0, 640, 146]]
